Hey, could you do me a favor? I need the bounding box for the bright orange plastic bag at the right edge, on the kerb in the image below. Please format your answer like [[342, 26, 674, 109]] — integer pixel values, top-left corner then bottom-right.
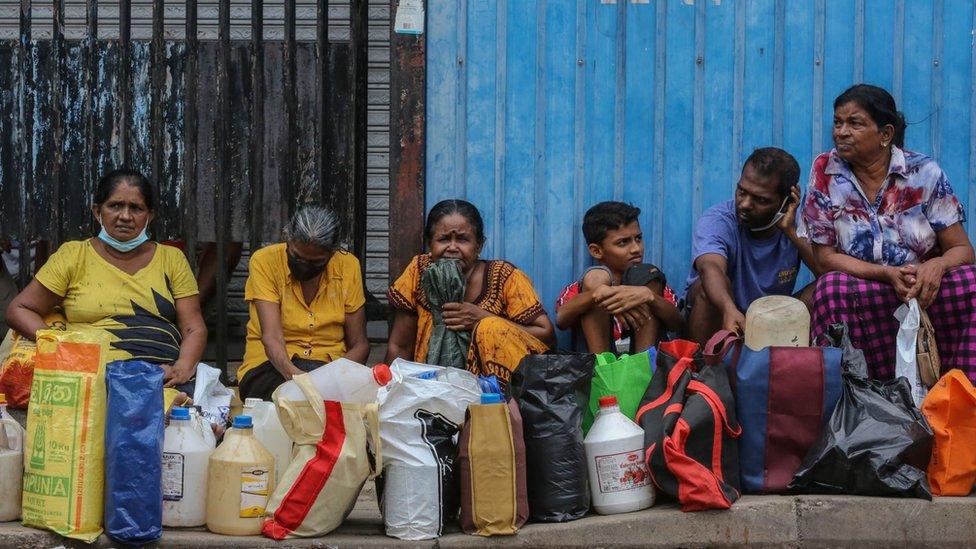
[[922, 370, 976, 496]]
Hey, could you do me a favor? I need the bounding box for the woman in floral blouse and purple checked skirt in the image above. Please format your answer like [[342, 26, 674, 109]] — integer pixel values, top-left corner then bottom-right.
[[803, 84, 976, 381]]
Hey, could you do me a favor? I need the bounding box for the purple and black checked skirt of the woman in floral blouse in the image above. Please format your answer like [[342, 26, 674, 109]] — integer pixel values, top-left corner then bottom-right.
[[810, 265, 976, 382]]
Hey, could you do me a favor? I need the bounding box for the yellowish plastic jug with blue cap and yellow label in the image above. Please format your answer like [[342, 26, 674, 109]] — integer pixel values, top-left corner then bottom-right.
[[207, 416, 275, 536]]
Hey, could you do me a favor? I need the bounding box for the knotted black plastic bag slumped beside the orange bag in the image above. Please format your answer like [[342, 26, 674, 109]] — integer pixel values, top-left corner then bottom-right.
[[789, 324, 933, 500]]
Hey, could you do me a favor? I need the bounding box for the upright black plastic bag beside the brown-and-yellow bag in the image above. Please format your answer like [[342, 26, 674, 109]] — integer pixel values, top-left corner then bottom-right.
[[509, 353, 594, 522]]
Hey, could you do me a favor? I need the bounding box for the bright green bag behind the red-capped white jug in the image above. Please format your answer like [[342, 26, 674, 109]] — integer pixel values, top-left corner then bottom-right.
[[583, 347, 657, 435]]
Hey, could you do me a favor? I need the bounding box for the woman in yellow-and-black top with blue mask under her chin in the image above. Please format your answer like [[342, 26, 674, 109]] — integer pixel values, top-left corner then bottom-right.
[[7, 169, 207, 394]]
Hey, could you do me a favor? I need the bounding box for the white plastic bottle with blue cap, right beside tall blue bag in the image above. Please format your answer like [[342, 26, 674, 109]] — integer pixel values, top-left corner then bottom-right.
[[163, 408, 214, 527]]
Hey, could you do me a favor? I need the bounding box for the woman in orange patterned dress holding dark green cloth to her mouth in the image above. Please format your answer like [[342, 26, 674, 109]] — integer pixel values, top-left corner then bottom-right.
[[386, 200, 555, 385]]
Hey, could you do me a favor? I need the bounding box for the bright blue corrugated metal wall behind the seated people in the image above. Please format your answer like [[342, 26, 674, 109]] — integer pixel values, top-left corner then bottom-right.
[[426, 0, 976, 326]]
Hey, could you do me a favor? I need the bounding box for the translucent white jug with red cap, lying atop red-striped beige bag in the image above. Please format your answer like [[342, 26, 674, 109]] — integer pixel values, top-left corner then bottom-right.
[[275, 358, 393, 404]]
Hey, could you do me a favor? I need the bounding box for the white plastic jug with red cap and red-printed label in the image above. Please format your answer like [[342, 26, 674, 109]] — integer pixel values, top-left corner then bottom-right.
[[583, 395, 654, 515]]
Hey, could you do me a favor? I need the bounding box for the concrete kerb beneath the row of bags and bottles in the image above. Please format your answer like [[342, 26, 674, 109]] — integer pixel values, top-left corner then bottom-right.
[[0, 490, 976, 549]]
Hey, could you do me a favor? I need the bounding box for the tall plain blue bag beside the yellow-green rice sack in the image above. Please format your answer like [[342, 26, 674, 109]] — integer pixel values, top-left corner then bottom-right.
[[105, 360, 164, 544]]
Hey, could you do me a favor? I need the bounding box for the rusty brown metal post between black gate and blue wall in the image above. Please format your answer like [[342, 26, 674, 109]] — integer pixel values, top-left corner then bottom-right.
[[389, 9, 427, 282]]
